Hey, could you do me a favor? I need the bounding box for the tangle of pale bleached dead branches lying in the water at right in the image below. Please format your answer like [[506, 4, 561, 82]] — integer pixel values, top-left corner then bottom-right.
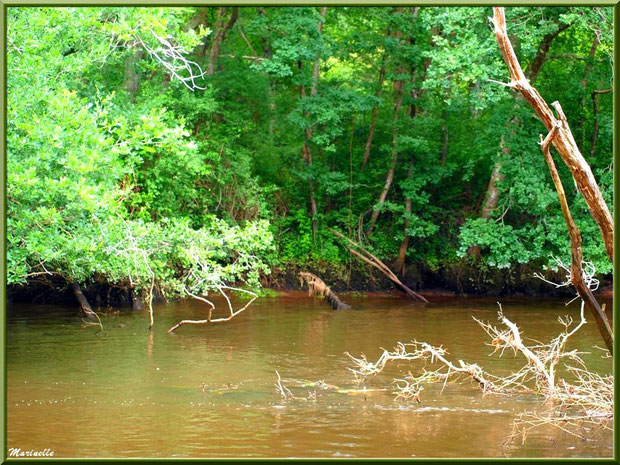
[[345, 302, 614, 440]]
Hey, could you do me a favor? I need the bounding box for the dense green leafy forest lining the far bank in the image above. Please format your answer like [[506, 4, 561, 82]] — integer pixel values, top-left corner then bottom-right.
[[6, 6, 613, 300]]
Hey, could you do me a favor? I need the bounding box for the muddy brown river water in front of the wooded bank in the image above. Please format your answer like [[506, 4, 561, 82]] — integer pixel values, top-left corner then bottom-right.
[[6, 293, 613, 458]]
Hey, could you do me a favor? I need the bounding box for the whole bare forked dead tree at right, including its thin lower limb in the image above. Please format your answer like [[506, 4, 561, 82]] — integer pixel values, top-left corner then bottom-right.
[[492, 7, 614, 353]]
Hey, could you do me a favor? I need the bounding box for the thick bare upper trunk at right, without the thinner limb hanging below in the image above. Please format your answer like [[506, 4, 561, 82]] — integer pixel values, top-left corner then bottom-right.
[[493, 7, 614, 263]]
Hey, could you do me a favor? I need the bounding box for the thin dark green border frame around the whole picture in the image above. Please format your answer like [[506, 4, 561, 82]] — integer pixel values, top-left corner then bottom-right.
[[0, 0, 620, 463]]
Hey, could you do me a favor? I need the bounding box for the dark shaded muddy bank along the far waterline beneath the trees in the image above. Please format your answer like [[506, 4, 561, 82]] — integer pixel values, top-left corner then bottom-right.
[[7, 263, 613, 310]]
